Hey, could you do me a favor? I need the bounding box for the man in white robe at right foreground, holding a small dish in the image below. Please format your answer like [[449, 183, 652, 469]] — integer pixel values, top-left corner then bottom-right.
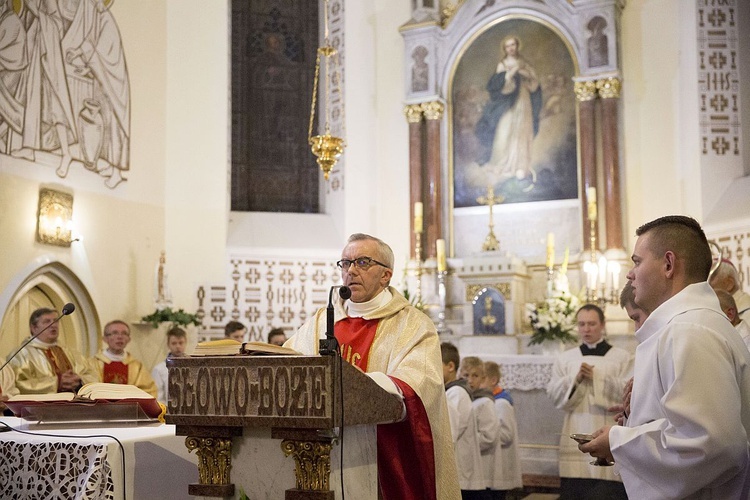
[[579, 216, 750, 500]]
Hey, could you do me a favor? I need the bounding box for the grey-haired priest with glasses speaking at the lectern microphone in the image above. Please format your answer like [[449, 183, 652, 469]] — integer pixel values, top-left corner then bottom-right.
[[285, 233, 460, 500]]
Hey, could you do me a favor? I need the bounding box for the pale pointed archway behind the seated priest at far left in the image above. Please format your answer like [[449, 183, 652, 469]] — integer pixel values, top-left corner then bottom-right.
[[0, 262, 100, 358]]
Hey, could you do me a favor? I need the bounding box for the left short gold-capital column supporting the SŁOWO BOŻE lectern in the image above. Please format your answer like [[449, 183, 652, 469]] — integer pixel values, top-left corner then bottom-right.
[[185, 436, 234, 497]]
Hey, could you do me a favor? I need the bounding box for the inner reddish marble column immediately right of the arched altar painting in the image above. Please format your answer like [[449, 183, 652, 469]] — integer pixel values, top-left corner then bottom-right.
[[574, 80, 598, 250]]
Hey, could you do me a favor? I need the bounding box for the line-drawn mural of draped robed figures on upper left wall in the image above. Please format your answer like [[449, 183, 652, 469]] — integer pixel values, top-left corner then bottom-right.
[[0, 0, 130, 189]]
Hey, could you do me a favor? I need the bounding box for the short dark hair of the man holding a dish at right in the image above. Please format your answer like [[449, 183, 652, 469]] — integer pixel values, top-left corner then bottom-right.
[[635, 215, 712, 283]]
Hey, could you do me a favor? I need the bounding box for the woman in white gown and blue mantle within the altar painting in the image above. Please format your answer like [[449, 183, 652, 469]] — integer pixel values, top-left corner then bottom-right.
[[476, 36, 542, 186]]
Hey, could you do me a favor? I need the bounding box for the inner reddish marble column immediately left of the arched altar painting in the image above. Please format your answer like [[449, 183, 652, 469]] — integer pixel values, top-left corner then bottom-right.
[[422, 101, 444, 258]]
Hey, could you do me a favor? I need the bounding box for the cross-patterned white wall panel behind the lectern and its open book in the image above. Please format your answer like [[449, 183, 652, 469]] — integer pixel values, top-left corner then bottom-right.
[[196, 255, 341, 341]]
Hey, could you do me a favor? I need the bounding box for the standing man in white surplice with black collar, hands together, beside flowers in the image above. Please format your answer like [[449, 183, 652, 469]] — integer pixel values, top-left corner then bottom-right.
[[547, 304, 633, 500]]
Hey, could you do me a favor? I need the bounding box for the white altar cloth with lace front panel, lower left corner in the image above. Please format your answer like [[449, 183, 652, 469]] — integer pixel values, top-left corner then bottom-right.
[[0, 417, 198, 500]]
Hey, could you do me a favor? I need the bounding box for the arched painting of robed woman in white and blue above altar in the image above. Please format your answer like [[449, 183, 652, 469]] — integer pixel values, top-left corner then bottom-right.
[[451, 18, 578, 208]]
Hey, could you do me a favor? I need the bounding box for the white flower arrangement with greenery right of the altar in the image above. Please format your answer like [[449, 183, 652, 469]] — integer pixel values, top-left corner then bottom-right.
[[526, 292, 581, 346]]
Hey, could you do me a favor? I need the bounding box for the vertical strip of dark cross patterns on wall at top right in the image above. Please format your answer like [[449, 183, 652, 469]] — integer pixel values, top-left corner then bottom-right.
[[697, 0, 741, 157]]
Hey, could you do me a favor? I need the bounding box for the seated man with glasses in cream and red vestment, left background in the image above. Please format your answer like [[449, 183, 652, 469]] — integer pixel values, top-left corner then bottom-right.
[[92, 319, 156, 397]]
